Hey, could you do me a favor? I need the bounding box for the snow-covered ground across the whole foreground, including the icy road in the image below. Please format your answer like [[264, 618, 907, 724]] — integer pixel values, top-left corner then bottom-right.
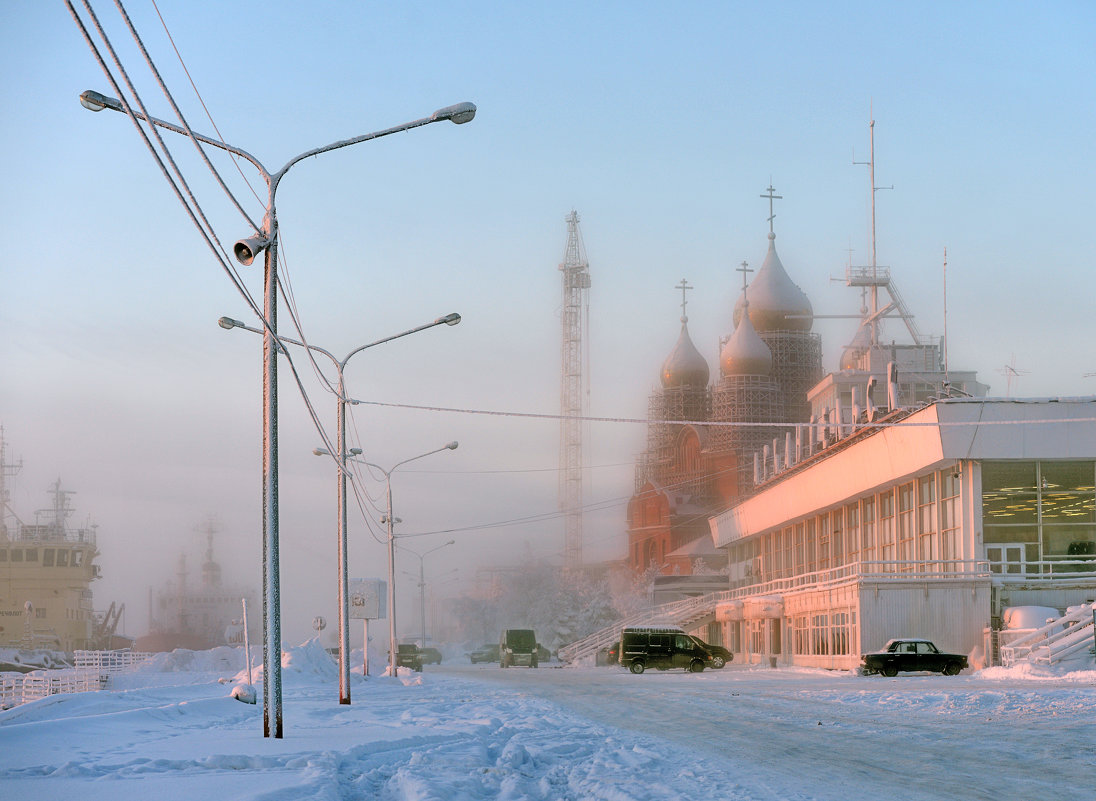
[[0, 641, 1096, 801]]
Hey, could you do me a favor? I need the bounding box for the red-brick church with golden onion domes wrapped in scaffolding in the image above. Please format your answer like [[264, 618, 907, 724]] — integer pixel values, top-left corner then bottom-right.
[[628, 187, 822, 575]]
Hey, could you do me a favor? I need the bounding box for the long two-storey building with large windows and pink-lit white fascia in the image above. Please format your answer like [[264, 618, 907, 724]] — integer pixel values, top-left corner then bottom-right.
[[709, 398, 1096, 668]]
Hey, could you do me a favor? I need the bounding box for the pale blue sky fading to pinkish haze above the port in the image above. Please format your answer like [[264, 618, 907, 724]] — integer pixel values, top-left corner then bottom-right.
[[0, 0, 1096, 637]]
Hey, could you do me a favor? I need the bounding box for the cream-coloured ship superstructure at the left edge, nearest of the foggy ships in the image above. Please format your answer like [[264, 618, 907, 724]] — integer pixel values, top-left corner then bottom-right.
[[0, 428, 125, 662]]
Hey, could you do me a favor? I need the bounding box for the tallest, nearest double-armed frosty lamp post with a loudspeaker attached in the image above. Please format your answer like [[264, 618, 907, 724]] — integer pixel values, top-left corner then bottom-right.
[[80, 90, 476, 737]]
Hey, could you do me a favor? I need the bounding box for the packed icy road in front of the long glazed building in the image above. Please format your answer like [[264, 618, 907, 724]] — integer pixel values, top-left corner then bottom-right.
[[447, 666, 1096, 800]]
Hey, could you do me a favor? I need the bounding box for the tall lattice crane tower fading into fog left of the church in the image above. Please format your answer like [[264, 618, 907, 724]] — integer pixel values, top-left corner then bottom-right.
[[559, 209, 590, 570]]
